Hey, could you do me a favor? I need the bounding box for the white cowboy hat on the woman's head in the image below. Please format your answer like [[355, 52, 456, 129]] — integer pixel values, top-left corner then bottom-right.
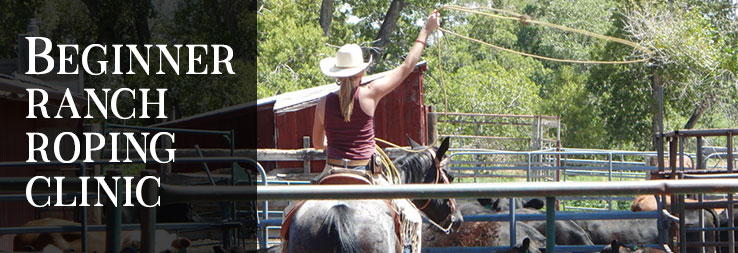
[[320, 44, 372, 78]]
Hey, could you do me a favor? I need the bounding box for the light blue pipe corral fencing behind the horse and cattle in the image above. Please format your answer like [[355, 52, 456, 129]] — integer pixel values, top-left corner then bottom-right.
[[254, 144, 728, 251]]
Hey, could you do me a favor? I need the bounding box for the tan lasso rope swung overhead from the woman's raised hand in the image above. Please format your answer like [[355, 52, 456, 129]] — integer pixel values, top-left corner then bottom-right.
[[436, 5, 652, 111]]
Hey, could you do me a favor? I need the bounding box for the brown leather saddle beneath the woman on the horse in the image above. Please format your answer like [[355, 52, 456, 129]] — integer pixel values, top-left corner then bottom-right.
[[280, 173, 402, 246]]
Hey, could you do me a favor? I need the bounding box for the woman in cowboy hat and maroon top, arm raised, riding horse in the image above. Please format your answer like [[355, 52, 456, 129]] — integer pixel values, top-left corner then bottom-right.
[[292, 12, 441, 252]]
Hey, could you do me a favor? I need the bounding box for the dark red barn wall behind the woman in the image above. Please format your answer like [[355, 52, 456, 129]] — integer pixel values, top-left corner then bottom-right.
[[274, 63, 428, 172]]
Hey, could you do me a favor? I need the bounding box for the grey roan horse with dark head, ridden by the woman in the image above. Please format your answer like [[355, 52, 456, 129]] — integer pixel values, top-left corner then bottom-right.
[[282, 138, 461, 252]]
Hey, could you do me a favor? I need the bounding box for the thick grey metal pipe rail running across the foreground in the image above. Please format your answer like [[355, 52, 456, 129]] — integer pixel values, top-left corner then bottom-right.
[[256, 179, 738, 252]]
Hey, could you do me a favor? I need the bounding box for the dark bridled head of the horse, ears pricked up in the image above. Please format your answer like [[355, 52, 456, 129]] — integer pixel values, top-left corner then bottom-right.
[[394, 138, 463, 230]]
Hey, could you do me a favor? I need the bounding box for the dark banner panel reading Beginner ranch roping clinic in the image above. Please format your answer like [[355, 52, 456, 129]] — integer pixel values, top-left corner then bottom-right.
[[0, 0, 260, 252]]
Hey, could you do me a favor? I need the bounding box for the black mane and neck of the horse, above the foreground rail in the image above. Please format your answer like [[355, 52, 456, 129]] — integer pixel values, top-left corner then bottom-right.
[[393, 148, 435, 184]]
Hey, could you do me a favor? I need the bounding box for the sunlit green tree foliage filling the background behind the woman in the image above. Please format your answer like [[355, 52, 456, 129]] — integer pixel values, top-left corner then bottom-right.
[[258, 0, 738, 150]]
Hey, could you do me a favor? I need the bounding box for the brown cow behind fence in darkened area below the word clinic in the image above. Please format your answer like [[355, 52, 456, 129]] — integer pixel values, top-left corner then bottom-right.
[[13, 218, 190, 252]]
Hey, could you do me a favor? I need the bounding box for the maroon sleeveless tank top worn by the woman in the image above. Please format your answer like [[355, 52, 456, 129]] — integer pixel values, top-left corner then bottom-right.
[[324, 88, 376, 160]]
